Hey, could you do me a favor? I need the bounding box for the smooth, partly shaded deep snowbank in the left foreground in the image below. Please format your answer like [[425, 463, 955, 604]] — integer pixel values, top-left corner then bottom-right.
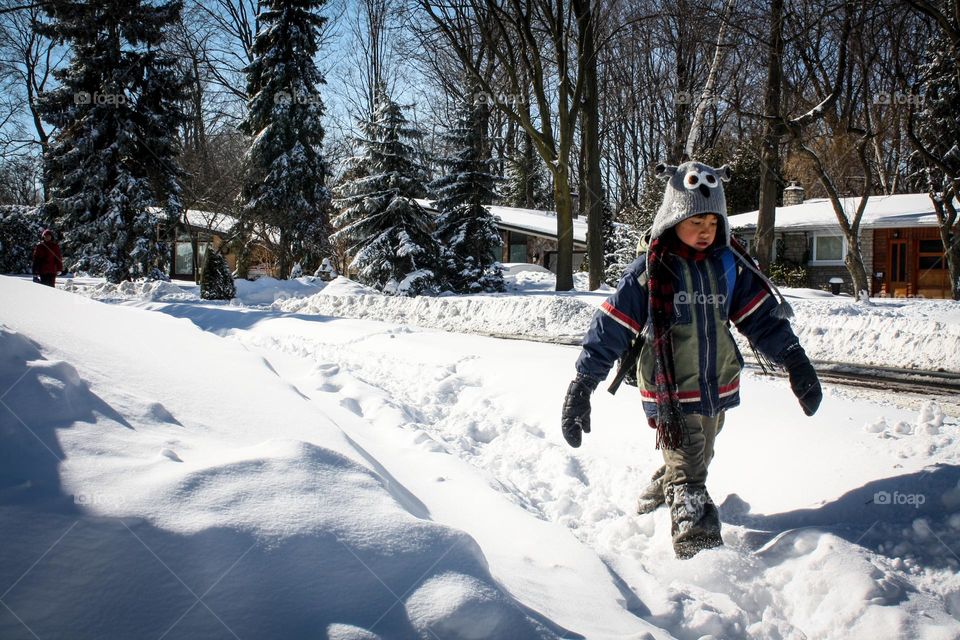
[[0, 278, 557, 639]]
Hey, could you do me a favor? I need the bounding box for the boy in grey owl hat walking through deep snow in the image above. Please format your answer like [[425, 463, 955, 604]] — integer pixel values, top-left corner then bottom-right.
[[562, 162, 823, 558]]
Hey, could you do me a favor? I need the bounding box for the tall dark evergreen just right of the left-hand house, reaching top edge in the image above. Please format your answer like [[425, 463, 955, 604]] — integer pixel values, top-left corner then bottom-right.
[[241, 0, 330, 278]]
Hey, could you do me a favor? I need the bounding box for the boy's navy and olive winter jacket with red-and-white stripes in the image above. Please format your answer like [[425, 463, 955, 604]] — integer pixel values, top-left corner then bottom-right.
[[577, 247, 799, 417]]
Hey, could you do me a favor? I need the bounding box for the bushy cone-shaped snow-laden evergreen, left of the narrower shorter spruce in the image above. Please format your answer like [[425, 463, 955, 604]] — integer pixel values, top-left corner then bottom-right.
[[332, 86, 439, 295]]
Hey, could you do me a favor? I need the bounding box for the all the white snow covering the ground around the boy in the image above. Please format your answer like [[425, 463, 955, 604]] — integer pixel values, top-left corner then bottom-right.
[[0, 276, 960, 640]]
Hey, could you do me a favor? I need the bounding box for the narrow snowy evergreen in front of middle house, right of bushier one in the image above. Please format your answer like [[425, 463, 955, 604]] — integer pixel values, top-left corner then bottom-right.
[[428, 92, 503, 293]]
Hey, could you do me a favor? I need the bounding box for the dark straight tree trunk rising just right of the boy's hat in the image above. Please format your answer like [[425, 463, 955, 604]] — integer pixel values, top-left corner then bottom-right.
[[753, 0, 783, 271]]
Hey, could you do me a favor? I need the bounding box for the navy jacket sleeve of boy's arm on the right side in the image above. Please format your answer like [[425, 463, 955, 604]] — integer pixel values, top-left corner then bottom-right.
[[730, 262, 800, 364]]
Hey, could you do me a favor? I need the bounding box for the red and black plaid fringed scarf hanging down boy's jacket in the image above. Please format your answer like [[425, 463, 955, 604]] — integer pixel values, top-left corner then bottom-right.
[[647, 233, 707, 449]]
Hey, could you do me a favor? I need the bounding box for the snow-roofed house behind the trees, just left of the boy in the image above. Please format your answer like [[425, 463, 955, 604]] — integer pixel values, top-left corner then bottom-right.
[[417, 200, 587, 273]]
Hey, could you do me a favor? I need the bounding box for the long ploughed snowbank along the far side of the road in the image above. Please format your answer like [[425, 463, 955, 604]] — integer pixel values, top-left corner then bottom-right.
[[48, 270, 960, 373]]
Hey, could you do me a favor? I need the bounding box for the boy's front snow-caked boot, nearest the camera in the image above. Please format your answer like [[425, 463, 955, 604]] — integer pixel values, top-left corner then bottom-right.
[[670, 484, 723, 560]]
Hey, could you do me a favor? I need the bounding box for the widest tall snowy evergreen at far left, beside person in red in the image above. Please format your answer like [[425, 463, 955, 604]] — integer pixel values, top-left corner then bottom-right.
[[37, 0, 185, 282]]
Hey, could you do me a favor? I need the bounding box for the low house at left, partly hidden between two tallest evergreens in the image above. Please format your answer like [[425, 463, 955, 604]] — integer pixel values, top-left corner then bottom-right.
[[169, 209, 276, 282]]
